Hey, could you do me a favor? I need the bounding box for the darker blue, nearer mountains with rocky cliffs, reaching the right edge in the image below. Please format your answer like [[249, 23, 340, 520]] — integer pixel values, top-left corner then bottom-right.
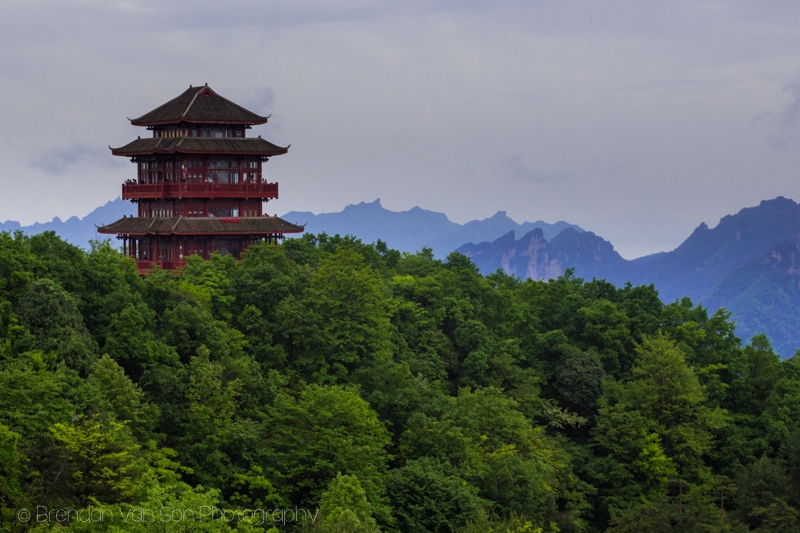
[[457, 197, 800, 356]]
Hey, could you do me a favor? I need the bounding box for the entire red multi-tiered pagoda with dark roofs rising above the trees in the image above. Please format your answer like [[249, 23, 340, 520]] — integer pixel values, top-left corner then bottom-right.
[[98, 84, 303, 272]]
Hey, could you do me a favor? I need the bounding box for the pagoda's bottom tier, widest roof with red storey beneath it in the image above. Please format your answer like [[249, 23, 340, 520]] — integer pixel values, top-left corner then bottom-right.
[[97, 216, 304, 273]]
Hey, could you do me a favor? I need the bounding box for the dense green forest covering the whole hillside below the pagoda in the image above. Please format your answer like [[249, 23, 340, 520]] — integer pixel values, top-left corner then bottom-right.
[[0, 233, 800, 533]]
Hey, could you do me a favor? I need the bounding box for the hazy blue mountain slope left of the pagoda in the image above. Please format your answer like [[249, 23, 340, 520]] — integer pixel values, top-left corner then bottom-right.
[[0, 198, 136, 250]]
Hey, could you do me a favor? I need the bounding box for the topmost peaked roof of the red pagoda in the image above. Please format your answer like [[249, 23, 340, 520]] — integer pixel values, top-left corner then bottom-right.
[[131, 84, 269, 126]]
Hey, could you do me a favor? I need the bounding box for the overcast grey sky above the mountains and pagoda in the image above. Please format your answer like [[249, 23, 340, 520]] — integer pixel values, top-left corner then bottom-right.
[[0, 0, 800, 258]]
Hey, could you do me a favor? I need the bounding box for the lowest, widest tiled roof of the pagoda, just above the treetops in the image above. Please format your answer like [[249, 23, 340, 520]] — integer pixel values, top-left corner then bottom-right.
[[97, 217, 305, 235]]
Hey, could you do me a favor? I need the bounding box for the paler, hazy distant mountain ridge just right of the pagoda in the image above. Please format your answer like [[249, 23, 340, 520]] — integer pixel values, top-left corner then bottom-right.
[[281, 199, 583, 258]]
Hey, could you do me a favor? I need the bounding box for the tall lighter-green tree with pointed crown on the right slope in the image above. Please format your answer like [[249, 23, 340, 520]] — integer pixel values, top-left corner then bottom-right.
[[592, 335, 724, 524]]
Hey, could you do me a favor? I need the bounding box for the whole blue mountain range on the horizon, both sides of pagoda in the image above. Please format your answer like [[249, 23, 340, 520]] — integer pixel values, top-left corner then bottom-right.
[[0, 197, 800, 356]]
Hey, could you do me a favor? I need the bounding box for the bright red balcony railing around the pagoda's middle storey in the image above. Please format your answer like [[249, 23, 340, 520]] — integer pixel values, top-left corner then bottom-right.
[[122, 182, 278, 200]]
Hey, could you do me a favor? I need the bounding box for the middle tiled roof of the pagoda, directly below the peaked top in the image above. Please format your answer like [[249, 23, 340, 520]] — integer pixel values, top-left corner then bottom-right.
[[109, 137, 289, 157]]
